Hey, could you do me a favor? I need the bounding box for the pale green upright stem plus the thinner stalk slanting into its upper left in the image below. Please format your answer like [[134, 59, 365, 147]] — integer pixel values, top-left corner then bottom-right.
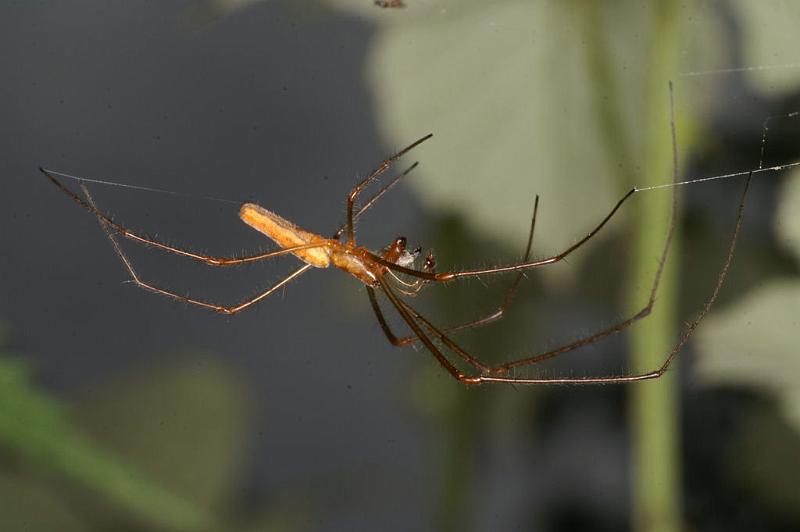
[[584, 1, 682, 532]]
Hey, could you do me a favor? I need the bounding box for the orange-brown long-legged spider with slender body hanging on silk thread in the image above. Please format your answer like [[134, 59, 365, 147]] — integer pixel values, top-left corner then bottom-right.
[[40, 95, 752, 384]]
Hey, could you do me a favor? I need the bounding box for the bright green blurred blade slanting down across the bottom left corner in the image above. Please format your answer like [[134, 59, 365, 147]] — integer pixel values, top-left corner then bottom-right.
[[0, 359, 210, 530]]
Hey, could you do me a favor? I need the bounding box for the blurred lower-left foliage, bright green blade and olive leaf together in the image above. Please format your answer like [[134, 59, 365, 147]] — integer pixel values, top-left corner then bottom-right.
[[0, 324, 266, 530]]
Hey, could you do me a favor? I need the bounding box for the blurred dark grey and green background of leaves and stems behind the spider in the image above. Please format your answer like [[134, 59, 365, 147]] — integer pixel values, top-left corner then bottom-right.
[[0, 0, 800, 531]]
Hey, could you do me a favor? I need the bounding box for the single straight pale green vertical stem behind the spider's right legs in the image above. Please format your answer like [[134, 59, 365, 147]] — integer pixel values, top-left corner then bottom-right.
[[629, 1, 682, 532]]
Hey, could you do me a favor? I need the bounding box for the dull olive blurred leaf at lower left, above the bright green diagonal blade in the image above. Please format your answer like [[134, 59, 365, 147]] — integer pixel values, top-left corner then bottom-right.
[[76, 353, 250, 512]]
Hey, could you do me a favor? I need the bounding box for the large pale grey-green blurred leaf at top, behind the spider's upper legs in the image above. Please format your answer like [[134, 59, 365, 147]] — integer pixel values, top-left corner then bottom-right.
[[367, 1, 732, 273]]
